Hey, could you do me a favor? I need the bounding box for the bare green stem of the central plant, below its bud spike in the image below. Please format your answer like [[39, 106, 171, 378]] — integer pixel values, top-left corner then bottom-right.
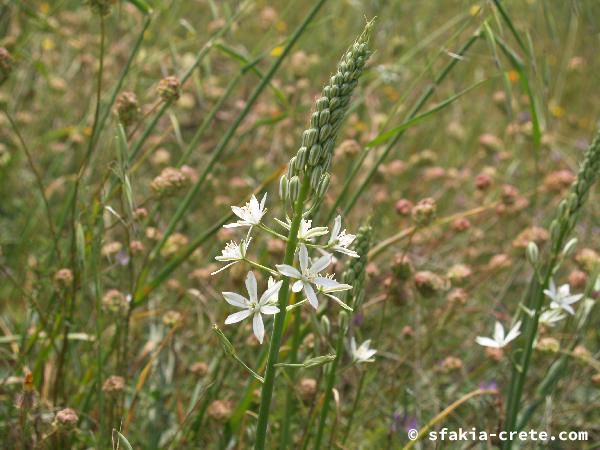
[[254, 178, 310, 450]]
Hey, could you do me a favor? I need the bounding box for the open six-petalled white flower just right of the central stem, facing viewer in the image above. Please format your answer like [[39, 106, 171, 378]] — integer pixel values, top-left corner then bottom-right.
[[277, 245, 351, 309]]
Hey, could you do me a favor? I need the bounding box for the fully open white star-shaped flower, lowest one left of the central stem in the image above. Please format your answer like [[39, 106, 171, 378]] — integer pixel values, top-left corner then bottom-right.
[[222, 272, 282, 344]]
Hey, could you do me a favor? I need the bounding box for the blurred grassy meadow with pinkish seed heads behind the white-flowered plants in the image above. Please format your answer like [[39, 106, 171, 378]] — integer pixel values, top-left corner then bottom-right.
[[0, 0, 600, 449]]
